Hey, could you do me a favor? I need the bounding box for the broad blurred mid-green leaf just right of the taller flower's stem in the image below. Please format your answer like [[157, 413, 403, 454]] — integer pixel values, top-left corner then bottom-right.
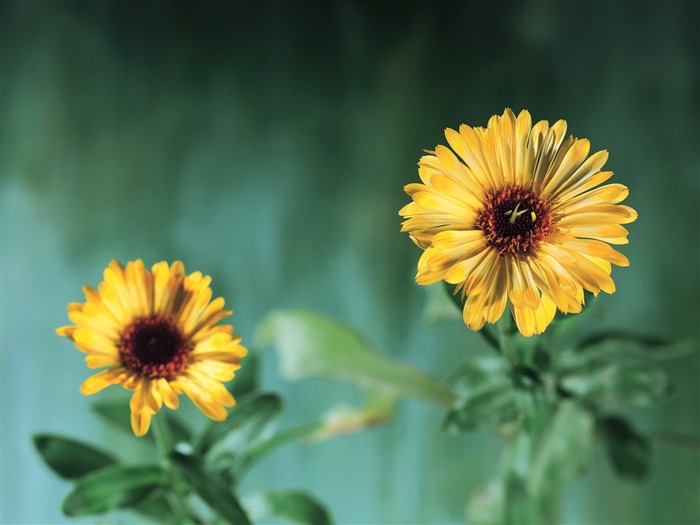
[[560, 359, 670, 405]]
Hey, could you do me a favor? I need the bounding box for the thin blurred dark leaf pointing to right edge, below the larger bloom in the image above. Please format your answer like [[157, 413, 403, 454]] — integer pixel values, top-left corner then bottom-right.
[[578, 331, 698, 359]]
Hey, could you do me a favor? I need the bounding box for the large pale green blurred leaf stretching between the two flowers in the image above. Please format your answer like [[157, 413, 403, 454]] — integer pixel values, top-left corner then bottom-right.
[[257, 310, 451, 404]]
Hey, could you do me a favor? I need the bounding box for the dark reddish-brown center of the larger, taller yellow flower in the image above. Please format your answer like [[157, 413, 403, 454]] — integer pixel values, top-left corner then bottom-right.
[[476, 186, 551, 255]]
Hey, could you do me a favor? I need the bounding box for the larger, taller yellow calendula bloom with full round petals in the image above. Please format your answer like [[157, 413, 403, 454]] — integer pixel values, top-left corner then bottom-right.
[[399, 109, 637, 336]]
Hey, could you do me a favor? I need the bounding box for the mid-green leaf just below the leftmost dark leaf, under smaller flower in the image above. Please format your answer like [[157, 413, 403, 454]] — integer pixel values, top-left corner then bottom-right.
[[62, 465, 167, 516]]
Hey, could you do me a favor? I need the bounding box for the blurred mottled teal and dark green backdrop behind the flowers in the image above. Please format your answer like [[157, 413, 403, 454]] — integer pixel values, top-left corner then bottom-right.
[[1, 1, 700, 524]]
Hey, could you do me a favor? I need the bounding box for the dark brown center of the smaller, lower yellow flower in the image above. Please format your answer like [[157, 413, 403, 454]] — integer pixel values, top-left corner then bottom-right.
[[119, 317, 190, 379]]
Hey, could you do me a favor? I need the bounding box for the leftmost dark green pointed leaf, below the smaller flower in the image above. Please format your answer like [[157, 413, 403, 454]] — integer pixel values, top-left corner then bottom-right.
[[32, 434, 117, 479]]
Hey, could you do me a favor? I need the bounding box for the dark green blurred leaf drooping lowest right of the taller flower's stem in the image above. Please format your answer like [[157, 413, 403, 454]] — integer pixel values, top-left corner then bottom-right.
[[598, 416, 651, 481]]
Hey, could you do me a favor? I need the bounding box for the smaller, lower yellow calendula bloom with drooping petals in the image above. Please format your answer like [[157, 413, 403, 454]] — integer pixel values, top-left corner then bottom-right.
[[57, 260, 247, 436]]
